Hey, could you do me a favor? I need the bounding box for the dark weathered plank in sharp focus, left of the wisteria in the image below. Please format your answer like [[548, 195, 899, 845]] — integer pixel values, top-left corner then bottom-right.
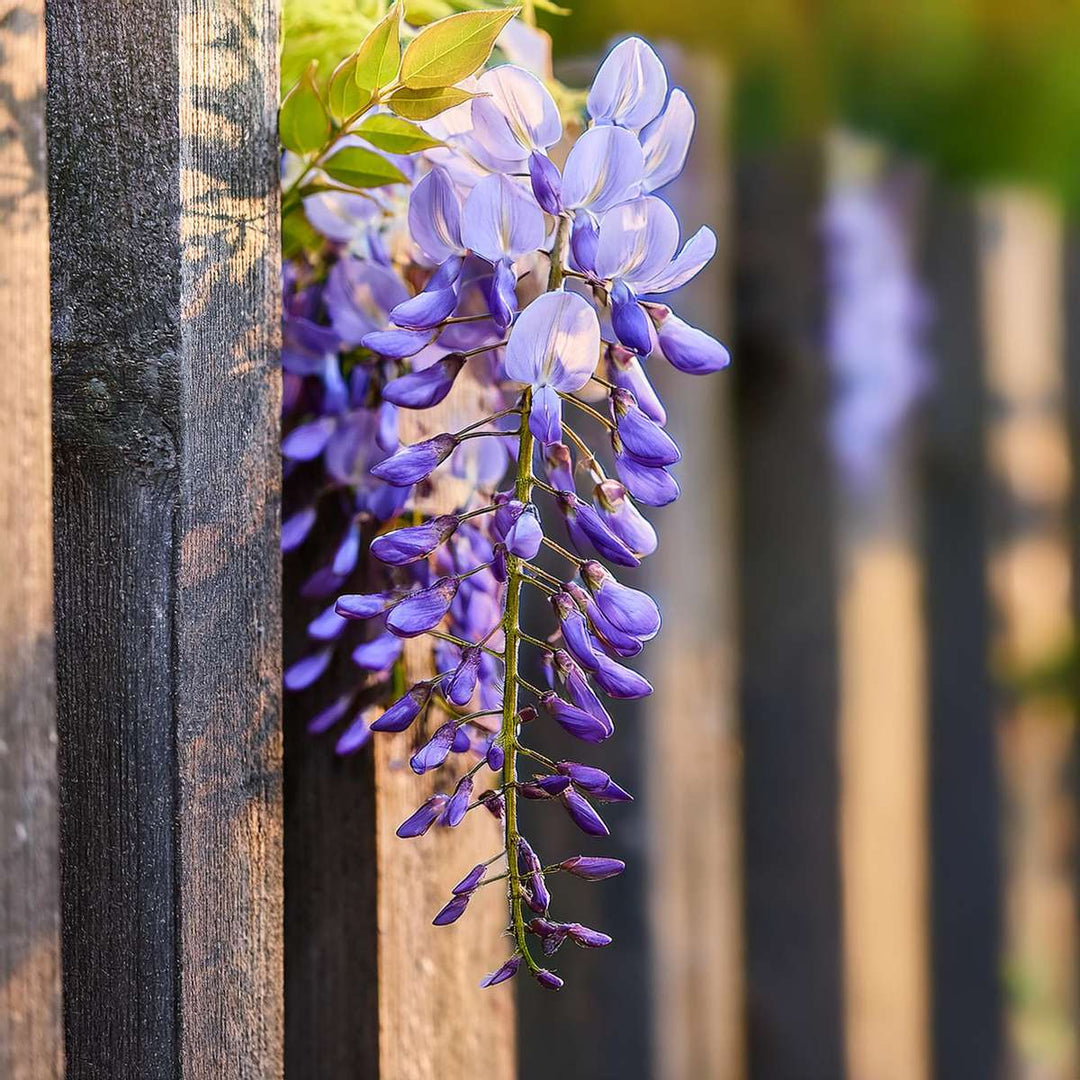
[[48, 0, 282, 1078]]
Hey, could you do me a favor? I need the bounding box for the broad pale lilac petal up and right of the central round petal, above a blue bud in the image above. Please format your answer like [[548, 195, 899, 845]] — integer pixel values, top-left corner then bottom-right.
[[596, 195, 678, 293]]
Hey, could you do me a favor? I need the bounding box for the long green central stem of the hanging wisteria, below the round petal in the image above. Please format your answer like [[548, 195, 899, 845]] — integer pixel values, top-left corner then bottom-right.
[[500, 386, 537, 971]]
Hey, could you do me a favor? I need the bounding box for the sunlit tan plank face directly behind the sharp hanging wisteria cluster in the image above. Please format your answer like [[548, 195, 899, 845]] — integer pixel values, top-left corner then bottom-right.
[[374, 379, 514, 1080]]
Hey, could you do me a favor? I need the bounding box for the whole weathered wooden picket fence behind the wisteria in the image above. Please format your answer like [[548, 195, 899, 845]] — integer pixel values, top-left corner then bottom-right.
[[6, 10, 1080, 1080]]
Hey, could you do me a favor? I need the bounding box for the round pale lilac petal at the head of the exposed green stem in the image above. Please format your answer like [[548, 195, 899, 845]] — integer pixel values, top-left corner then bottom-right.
[[505, 293, 600, 392]]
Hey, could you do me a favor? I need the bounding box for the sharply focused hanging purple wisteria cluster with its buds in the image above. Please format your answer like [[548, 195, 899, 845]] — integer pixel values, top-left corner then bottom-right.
[[283, 9, 728, 989]]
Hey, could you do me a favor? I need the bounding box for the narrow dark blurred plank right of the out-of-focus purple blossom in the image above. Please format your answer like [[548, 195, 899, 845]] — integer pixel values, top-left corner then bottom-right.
[[921, 185, 1002, 1077]]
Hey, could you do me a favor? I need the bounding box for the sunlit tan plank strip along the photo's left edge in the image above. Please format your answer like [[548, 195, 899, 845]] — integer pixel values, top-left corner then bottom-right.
[[0, 0, 64, 1080]]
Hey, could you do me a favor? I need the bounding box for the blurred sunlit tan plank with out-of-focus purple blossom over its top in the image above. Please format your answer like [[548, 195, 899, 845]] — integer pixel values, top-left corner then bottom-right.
[[827, 133, 930, 1080]]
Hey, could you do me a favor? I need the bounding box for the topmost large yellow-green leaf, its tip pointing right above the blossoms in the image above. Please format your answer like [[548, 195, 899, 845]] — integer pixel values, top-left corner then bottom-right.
[[401, 8, 521, 90]]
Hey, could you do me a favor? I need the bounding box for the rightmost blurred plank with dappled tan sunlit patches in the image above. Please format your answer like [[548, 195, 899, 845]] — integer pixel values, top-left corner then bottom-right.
[[980, 191, 1080, 1080]]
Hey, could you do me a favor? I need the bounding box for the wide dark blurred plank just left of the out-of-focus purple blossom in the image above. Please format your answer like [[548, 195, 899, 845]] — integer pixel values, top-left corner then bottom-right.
[[732, 148, 843, 1080]]
